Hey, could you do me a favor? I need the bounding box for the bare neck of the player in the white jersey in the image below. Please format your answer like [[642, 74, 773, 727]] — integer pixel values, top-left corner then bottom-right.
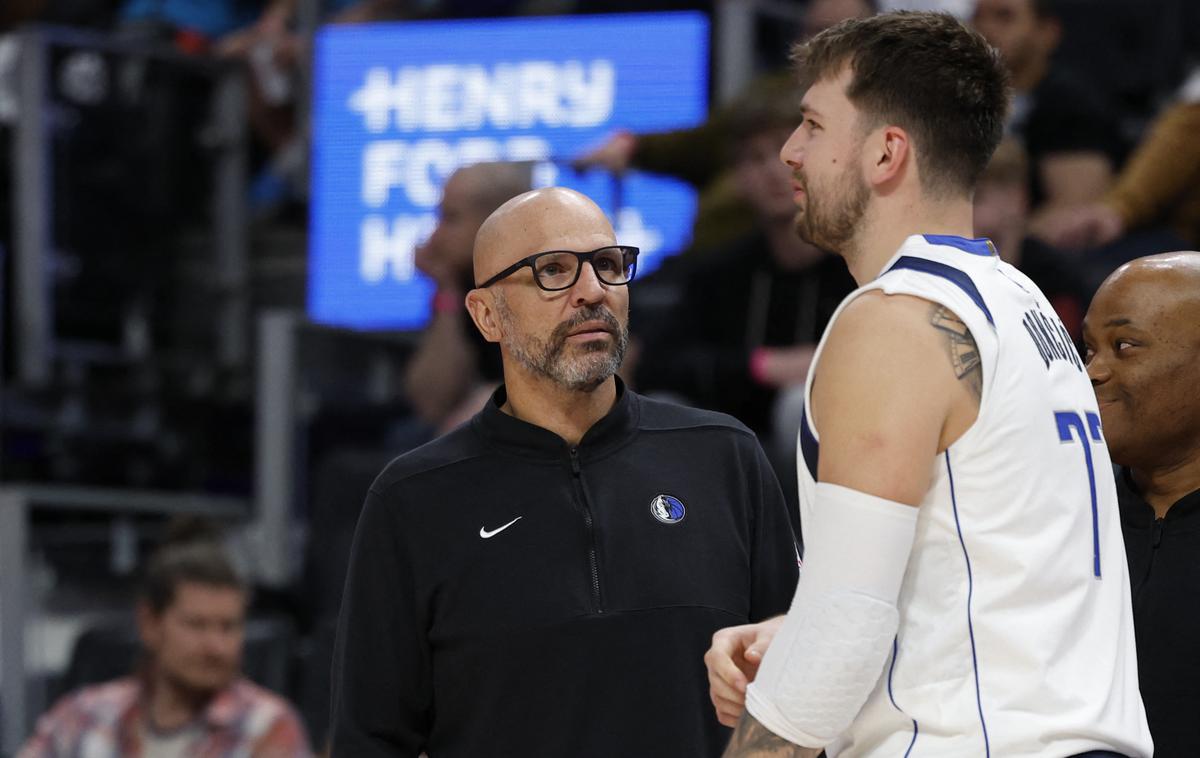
[[846, 198, 974, 285]]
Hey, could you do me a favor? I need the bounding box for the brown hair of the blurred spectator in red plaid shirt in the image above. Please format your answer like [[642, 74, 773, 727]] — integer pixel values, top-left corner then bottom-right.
[[140, 519, 247, 615]]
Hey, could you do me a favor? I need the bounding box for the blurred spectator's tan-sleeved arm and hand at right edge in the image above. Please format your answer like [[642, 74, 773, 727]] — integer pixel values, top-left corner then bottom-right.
[[1044, 68, 1200, 248]]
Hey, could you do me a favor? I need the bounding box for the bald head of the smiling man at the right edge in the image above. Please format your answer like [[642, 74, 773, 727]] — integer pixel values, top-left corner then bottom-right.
[[1084, 252, 1200, 470]]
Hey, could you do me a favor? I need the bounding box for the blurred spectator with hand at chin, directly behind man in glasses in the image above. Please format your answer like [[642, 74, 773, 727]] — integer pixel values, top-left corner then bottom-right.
[[405, 163, 532, 438]]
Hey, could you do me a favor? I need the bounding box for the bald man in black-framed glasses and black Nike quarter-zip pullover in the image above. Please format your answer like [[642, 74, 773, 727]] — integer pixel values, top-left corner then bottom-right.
[[332, 187, 797, 758]]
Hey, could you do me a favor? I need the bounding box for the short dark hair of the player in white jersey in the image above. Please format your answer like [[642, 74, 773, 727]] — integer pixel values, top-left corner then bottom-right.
[[792, 11, 1009, 195]]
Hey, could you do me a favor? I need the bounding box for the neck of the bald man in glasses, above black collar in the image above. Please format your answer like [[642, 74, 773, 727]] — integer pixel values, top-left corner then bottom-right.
[[500, 371, 617, 447]]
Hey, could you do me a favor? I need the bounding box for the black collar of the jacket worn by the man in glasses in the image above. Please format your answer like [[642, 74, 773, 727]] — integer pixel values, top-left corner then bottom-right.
[[473, 377, 640, 463]]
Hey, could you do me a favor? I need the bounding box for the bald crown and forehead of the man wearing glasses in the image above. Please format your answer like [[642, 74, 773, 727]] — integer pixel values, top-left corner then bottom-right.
[[475, 187, 617, 282]]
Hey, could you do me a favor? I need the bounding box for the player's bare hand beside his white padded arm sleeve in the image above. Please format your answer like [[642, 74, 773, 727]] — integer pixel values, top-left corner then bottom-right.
[[704, 616, 784, 727]]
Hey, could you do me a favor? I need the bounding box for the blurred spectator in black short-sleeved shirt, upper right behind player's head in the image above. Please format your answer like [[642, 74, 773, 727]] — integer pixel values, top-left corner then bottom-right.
[[973, 0, 1121, 212]]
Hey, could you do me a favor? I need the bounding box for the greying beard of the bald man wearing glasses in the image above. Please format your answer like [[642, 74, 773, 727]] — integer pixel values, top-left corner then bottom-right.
[[494, 293, 629, 392]]
